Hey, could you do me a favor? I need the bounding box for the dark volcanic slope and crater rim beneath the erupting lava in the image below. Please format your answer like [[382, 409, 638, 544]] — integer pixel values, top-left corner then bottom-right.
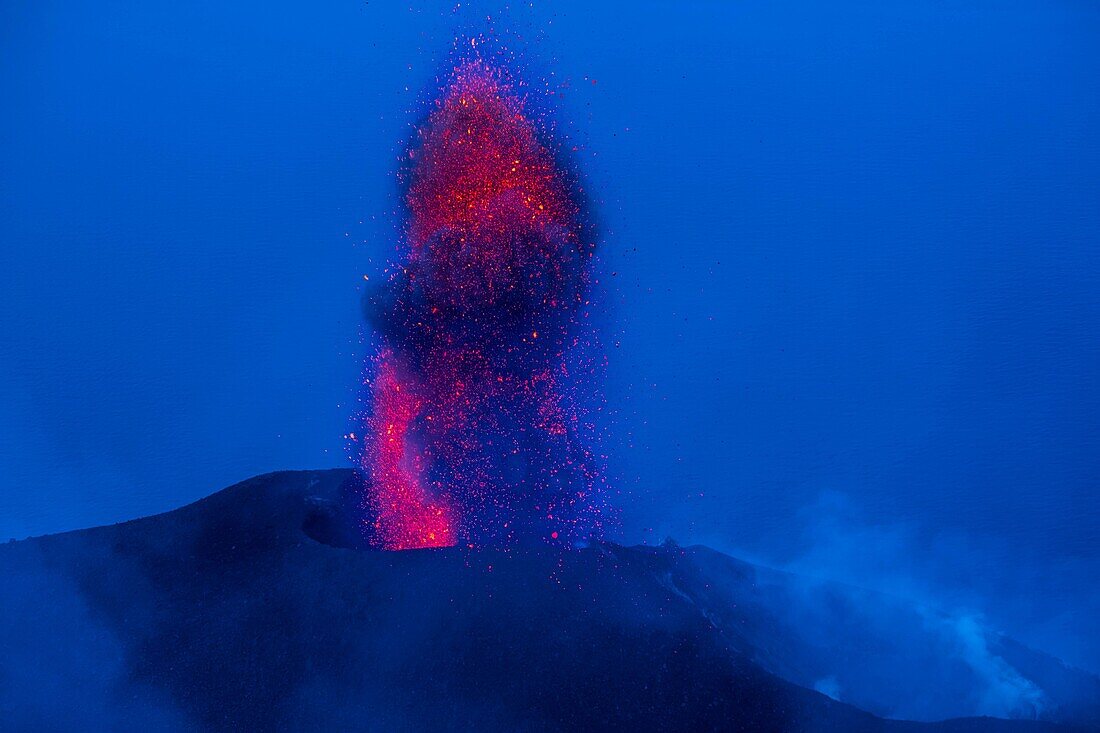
[[0, 470, 1091, 732]]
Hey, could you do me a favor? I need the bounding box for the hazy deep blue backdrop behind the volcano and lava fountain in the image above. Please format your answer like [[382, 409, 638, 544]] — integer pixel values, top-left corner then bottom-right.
[[0, 0, 1100, 671]]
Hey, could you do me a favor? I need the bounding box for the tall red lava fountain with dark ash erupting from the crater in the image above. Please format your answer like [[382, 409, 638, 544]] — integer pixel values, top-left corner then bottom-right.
[[358, 51, 606, 549]]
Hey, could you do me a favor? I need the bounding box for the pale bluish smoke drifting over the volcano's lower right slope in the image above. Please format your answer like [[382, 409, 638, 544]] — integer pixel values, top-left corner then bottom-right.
[[712, 493, 1100, 721]]
